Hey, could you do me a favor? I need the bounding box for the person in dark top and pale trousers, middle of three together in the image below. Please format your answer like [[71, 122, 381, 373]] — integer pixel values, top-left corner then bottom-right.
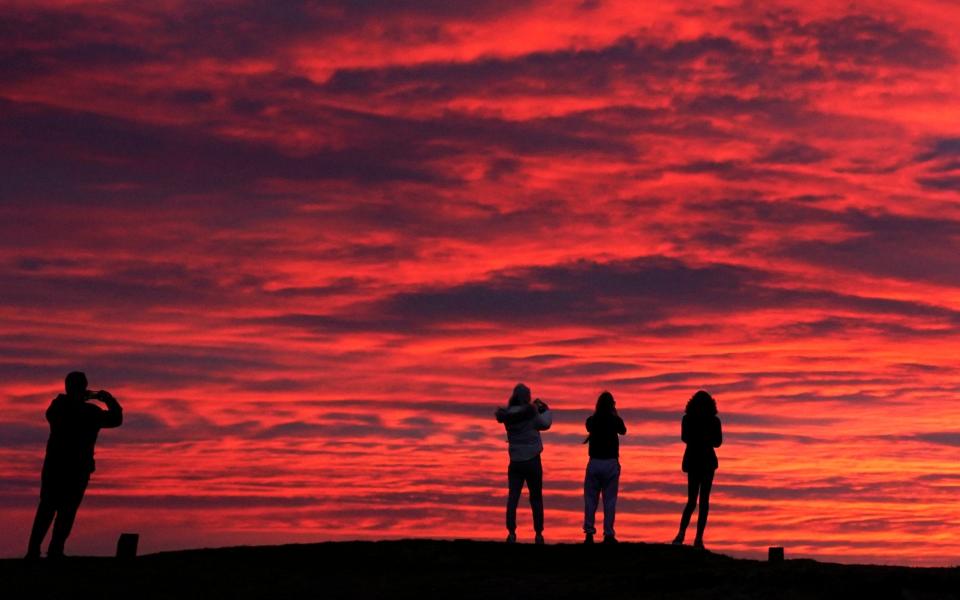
[[583, 392, 627, 544]]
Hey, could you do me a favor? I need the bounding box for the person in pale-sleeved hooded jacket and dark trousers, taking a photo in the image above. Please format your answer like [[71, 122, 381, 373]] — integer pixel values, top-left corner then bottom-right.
[[496, 383, 553, 544]]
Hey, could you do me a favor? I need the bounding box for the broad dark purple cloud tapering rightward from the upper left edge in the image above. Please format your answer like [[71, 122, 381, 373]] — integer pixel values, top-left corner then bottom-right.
[[0, 96, 462, 203]]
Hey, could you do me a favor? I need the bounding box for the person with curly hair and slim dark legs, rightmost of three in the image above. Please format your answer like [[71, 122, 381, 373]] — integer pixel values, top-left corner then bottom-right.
[[673, 390, 723, 548]]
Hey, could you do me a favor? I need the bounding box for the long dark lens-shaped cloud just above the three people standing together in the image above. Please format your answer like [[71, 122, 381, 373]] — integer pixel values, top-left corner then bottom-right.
[[254, 257, 960, 338]]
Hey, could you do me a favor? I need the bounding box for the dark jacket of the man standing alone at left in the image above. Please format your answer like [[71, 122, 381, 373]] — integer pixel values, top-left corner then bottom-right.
[[43, 394, 123, 475]]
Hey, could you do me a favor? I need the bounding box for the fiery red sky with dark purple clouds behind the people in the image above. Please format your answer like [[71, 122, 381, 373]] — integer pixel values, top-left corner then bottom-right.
[[0, 0, 960, 564]]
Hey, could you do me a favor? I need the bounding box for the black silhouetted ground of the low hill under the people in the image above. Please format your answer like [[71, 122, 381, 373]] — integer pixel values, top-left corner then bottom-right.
[[0, 540, 960, 600]]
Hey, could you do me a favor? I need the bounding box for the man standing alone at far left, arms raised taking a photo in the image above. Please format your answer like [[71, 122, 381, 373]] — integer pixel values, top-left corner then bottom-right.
[[27, 371, 123, 558]]
